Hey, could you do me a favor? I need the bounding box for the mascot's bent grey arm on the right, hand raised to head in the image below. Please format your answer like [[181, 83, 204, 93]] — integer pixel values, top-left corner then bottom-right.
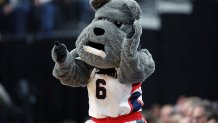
[[118, 21, 155, 83]]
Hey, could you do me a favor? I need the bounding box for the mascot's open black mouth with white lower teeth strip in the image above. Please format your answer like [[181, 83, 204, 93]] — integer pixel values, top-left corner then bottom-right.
[[83, 41, 106, 58]]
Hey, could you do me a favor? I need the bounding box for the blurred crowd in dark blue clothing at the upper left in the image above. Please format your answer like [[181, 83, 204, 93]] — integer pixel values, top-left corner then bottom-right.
[[0, 0, 92, 38]]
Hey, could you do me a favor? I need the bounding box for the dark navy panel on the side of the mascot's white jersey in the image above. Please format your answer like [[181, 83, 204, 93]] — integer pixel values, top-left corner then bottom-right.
[[130, 92, 142, 112]]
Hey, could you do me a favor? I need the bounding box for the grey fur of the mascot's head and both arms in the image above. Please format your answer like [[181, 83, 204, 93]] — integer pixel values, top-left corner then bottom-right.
[[52, 0, 155, 87]]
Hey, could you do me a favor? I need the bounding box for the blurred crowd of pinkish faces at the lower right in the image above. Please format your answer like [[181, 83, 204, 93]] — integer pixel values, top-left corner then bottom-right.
[[143, 96, 218, 123]]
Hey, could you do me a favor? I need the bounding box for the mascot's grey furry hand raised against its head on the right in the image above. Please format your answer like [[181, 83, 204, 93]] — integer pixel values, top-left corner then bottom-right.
[[122, 21, 142, 55]]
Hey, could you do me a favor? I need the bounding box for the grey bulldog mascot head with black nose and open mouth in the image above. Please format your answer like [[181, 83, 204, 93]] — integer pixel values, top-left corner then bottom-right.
[[76, 0, 141, 68]]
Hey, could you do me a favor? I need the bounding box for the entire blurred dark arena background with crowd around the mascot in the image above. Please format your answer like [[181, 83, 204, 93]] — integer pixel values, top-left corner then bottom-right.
[[0, 0, 218, 123]]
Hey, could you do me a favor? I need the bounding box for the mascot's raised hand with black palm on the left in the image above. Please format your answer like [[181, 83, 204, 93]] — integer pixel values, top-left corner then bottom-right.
[[52, 41, 67, 63]]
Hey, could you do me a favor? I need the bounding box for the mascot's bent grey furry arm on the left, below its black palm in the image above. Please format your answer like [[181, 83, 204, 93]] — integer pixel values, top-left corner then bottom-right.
[[52, 47, 93, 87]]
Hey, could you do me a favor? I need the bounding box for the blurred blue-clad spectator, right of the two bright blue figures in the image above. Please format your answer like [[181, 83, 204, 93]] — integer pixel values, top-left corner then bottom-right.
[[34, 0, 55, 38]]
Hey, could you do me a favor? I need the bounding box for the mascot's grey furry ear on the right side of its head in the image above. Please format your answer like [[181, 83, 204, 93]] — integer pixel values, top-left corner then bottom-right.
[[125, 0, 142, 20]]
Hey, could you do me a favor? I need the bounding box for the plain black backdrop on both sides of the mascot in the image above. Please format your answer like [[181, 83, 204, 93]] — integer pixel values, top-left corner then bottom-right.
[[0, 1, 218, 123]]
